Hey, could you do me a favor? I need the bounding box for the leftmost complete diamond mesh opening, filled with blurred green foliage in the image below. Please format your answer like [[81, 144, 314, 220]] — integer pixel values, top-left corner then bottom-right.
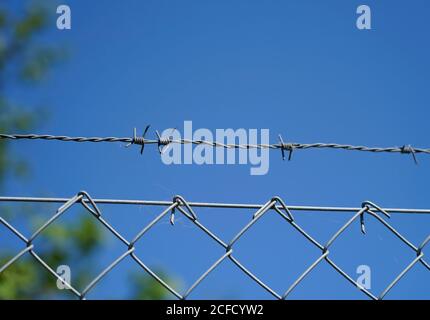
[[27, 203, 127, 298]]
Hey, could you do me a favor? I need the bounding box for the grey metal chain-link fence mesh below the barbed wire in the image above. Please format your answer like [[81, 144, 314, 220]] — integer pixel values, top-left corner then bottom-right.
[[0, 191, 430, 300]]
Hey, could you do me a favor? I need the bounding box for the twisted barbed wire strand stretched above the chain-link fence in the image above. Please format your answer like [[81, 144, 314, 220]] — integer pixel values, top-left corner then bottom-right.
[[0, 126, 430, 163]]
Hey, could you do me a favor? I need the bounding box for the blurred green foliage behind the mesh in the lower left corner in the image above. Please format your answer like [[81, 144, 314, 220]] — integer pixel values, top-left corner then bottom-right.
[[0, 215, 102, 299]]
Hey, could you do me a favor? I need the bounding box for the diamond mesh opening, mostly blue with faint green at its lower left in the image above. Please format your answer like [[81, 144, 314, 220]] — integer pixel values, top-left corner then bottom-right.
[[135, 208, 225, 295]]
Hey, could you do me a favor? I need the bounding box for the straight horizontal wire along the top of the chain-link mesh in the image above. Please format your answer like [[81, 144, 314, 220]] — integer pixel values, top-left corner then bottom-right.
[[0, 196, 430, 214]]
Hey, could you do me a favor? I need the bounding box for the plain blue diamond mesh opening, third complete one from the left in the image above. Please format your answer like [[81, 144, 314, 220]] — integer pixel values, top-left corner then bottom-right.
[[228, 210, 321, 296]]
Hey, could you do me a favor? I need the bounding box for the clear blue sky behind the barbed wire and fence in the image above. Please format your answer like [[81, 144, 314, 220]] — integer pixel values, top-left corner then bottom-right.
[[1, 0, 430, 299]]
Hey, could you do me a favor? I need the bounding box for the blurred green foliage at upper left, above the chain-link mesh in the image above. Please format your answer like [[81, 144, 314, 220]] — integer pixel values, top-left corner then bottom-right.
[[0, 4, 57, 187]]
